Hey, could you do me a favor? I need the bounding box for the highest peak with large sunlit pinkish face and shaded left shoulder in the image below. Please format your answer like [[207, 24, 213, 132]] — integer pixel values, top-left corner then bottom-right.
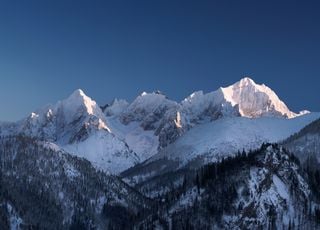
[[181, 77, 307, 120]]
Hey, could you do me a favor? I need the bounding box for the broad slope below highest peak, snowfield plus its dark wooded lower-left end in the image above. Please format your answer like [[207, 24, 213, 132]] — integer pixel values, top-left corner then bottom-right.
[[122, 113, 320, 184]]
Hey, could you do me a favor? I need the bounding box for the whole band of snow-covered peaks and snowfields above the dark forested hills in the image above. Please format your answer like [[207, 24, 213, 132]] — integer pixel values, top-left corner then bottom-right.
[[0, 78, 318, 173]]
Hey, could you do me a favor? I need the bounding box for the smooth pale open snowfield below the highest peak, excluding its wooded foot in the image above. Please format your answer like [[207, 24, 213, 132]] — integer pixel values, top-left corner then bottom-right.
[[154, 113, 320, 164]]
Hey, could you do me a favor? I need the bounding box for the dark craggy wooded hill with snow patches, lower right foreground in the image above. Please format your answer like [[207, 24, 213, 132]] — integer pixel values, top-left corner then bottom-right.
[[134, 144, 319, 229]]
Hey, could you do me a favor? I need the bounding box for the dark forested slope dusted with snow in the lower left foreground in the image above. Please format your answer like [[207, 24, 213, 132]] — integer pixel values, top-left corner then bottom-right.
[[0, 136, 151, 229]]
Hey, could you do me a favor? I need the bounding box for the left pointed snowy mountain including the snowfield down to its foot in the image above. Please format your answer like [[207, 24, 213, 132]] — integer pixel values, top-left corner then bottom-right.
[[0, 90, 139, 173]]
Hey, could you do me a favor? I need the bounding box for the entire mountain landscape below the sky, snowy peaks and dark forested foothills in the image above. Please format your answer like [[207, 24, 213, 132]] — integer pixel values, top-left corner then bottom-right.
[[0, 77, 320, 229]]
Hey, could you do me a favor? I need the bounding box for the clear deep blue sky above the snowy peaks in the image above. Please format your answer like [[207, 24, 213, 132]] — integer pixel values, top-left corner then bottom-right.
[[0, 0, 320, 120]]
